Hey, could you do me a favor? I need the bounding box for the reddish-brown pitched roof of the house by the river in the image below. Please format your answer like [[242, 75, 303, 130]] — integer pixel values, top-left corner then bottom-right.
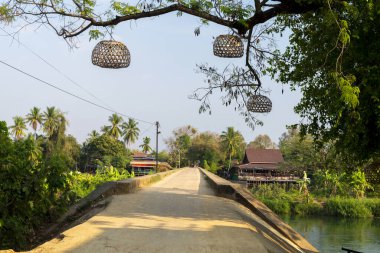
[[244, 148, 284, 164]]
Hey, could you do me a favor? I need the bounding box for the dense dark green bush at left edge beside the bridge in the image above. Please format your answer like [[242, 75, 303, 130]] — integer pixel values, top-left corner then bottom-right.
[[0, 122, 73, 249]]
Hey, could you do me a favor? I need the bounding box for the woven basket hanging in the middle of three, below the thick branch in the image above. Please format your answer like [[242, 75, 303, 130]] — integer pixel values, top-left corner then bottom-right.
[[214, 35, 244, 58]]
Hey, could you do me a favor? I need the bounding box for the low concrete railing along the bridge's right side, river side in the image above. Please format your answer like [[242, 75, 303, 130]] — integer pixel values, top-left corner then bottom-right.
[[199, 168, 319, 253]]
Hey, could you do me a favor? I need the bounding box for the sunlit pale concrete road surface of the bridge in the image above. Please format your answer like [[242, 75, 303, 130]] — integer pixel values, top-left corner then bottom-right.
[[32, 168, 302, 253]]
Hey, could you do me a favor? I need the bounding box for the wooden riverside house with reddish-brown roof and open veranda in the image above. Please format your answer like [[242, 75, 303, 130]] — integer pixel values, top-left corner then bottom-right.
[[229, 149, 299, 187]]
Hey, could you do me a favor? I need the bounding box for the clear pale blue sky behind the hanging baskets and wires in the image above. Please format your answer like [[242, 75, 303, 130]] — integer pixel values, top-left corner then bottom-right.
[[0, 13, 301, 147]]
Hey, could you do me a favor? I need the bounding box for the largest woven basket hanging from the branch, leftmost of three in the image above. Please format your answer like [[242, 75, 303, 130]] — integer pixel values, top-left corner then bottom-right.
[[91, 40, 131, 69]]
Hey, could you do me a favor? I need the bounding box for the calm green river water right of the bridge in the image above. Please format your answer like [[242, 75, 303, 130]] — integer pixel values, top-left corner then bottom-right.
[[282, 216, 380, 253]]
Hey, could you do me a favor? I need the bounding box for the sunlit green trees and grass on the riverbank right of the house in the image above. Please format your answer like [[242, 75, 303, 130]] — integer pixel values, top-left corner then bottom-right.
[[252, 128, 380, 217]]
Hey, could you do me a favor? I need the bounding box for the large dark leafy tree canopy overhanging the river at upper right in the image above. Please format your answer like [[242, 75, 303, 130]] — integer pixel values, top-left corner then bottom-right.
[[270, 0, 380, 164]]
